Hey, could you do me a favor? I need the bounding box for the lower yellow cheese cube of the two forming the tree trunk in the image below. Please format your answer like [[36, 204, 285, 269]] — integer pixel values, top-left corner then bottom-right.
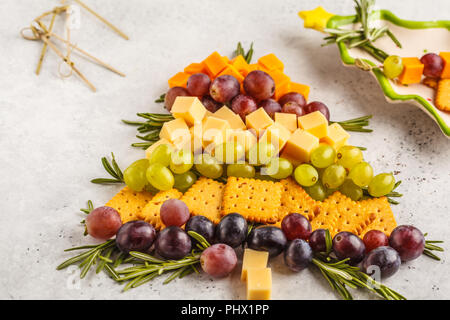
[[247, 268, 272, 300]]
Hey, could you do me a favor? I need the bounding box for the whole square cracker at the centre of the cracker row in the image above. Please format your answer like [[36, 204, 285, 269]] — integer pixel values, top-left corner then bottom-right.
[[222, 177, 283, 223]]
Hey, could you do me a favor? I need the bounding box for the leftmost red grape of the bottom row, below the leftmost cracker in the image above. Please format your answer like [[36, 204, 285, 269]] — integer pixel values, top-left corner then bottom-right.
[[86, 206, 122, 240]]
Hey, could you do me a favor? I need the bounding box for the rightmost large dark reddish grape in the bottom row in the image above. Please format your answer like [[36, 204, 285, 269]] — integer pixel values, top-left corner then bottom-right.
[[389, 225, 425, 261]]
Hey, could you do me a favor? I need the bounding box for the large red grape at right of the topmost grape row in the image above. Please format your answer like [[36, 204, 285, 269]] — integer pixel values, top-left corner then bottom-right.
[[244, 70, 275, 101]]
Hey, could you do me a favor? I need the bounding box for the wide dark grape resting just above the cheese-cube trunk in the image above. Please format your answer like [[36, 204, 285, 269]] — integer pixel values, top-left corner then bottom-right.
[[247, 226, 287, 257]]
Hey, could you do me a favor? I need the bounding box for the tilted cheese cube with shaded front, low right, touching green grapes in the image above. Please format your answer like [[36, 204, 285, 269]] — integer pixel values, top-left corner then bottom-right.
[[281, 129, 319, 163]]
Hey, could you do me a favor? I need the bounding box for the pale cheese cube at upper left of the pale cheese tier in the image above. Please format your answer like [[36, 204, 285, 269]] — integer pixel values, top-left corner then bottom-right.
[[170, 97, 207, 126]]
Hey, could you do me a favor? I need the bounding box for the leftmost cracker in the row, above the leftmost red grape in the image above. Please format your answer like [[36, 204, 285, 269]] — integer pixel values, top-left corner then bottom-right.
[[105, 187, 152, 223]]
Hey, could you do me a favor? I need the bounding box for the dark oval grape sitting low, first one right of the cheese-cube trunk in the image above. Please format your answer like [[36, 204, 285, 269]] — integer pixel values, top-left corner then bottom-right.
[[284, 239, 313, 272]]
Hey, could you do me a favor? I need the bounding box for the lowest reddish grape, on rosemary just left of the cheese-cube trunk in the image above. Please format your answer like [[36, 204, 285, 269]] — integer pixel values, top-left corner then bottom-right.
[[200, 243, 237, 278]]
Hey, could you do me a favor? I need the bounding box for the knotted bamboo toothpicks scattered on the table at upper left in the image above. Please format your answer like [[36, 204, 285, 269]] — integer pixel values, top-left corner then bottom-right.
[[20, 0, 128, 92]]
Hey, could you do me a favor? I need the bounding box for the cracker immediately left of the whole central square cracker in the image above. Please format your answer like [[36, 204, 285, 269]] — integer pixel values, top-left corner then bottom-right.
[[181, 177, 225, 224]]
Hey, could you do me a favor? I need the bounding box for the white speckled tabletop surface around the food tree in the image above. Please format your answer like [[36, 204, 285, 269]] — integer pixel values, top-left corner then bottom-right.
[[0, 0, 450, 299]]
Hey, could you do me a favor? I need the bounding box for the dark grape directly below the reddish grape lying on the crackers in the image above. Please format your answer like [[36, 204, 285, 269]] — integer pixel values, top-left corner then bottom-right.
[[155, 226, 192, 260]]
